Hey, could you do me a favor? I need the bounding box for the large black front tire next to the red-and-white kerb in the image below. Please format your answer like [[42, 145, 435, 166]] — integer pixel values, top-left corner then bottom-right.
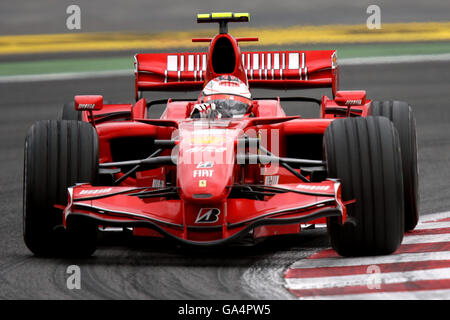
[[324, 117, 404, 256]]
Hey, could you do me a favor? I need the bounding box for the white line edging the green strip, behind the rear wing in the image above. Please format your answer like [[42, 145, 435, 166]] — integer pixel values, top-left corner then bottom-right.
[[0, 53, 450, 83]]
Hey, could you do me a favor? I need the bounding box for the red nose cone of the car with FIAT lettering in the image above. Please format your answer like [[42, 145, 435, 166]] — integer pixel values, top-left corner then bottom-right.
[[177, 122, 235, 203]]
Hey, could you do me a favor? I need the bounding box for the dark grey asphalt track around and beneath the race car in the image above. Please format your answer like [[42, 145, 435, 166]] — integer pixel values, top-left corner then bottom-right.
[[0, 62, 450, 299]]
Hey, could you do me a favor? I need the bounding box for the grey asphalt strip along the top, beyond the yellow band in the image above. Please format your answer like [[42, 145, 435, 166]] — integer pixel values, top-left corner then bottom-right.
[[0, 0, 450, 34]]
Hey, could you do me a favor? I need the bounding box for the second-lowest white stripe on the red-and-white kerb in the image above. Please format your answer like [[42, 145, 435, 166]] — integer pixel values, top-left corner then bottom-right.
[[286, 268, 450, 290]]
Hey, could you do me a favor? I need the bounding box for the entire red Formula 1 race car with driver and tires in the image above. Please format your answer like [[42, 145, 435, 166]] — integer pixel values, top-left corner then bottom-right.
[[23, 13, 418, 256]]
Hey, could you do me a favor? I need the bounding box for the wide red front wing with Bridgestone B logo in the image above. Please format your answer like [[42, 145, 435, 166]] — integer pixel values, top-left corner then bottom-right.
[[63, 180, 346, 245]]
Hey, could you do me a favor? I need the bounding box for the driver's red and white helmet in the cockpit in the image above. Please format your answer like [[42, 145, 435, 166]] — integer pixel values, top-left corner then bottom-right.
[[199, 76, 252, 118]]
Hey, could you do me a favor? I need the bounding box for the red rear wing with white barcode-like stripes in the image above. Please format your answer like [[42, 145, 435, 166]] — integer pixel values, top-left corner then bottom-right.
[[135, 50, 339, 96]]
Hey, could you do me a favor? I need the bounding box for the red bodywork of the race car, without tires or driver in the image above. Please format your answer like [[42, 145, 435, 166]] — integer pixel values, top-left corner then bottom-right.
[[64, 26, 370, 245]]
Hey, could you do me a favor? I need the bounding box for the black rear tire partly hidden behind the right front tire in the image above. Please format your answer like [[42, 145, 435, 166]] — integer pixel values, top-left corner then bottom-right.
[[369, 101, 419, 231]]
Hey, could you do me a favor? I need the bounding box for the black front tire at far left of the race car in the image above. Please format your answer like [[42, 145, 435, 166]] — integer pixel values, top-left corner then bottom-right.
[[23, 120, 98, 256]]
